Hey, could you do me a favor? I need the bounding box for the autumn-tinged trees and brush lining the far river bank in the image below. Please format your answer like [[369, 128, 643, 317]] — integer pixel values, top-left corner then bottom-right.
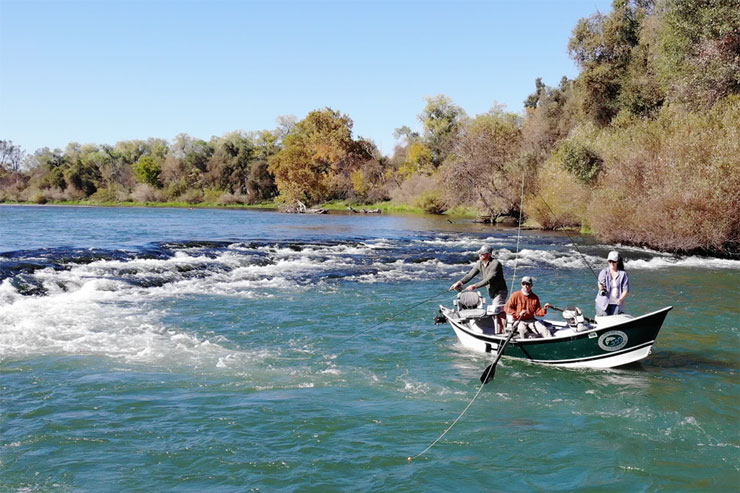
[[0, 0, 740, 254]]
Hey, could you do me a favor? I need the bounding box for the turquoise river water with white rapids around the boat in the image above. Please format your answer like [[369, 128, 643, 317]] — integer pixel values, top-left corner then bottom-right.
[[0, 206, 740, 491]]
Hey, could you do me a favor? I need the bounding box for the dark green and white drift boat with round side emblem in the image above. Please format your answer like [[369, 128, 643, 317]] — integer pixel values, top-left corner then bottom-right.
[[435, 292, 673, 368]]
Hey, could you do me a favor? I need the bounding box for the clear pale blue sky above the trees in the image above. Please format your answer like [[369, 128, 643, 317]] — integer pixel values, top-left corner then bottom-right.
[[0, 0, 611, 154]]
